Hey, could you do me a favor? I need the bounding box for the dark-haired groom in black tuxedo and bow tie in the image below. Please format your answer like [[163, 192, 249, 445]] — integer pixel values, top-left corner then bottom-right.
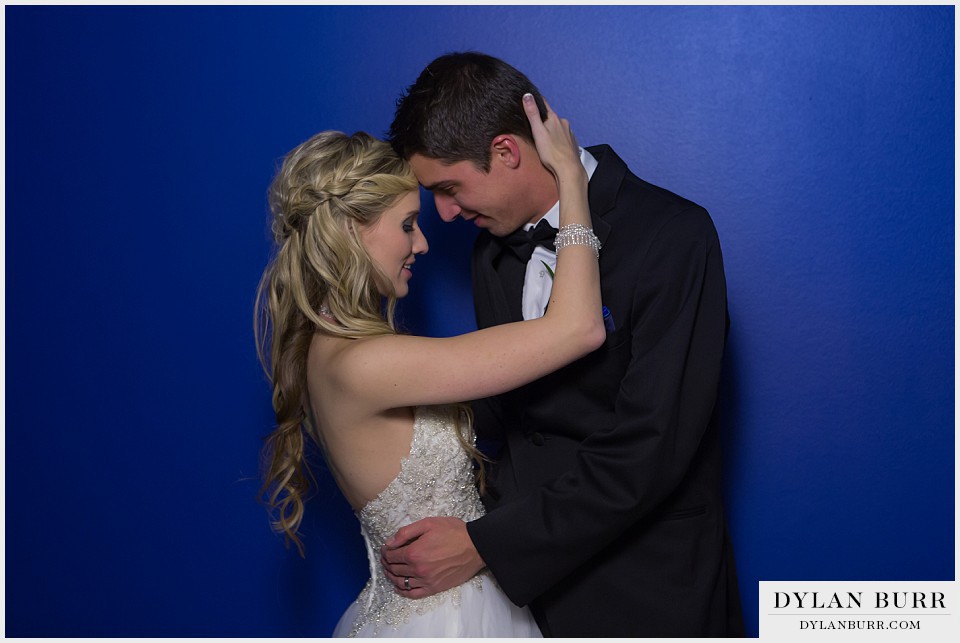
[[382, 53, 743, 637]]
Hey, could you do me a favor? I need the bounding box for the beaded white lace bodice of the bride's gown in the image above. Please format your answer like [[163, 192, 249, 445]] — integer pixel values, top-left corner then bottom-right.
[[353, 406, 483, 633]]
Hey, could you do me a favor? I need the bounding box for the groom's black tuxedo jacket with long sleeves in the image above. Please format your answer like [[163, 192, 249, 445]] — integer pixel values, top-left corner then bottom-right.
[[467, 145, 743, 637]]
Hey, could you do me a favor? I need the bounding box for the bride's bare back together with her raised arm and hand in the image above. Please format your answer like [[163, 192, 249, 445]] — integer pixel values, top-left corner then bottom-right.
[[307, 97, 605, 520]]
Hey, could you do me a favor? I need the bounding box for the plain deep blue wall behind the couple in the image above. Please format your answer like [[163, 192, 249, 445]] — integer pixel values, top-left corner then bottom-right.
[[5, 6, 955, 637]]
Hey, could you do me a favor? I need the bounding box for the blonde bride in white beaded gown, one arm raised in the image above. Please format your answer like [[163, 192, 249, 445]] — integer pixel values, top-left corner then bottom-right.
[[257, 97, 605, 637]]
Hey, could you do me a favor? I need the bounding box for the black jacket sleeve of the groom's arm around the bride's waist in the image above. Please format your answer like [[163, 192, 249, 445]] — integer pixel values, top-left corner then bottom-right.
[[467, 207, 727, 605]]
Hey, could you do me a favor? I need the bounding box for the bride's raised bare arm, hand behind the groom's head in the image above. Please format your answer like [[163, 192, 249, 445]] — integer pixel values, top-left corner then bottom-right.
[[331, 97, 605, 411]]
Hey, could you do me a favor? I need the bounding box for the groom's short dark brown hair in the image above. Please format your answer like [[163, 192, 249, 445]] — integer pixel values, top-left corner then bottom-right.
[[388, 51, 547, 172]]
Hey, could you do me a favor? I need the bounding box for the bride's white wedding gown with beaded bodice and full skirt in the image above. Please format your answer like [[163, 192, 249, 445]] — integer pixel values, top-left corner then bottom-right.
[[333, 406, 540, 638]]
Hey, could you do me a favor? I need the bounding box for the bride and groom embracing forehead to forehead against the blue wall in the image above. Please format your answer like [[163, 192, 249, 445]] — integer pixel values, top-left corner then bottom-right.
[[258, 52, 743, 637]]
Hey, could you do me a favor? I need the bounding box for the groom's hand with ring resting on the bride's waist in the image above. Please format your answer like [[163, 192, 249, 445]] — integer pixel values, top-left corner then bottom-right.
[[380, 518, 485, 598]]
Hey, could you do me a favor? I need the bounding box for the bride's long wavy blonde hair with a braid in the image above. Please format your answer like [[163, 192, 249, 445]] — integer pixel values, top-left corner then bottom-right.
[[254, 131, 482, 555]]
